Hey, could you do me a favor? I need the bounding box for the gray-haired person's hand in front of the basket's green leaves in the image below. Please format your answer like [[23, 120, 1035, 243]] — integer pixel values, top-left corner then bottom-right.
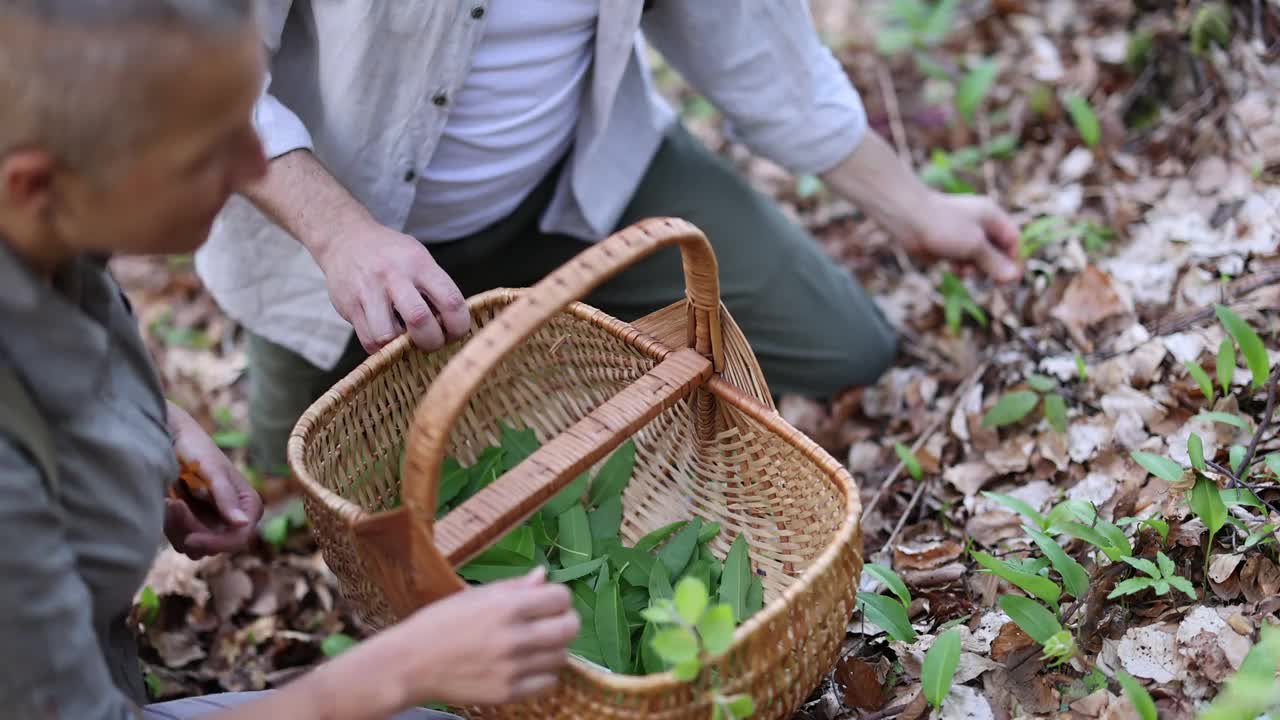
[[393, 566, 580, 706]]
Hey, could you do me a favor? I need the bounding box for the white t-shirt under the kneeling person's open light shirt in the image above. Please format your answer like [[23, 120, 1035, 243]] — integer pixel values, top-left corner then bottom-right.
[[404, 0, 599, 242]]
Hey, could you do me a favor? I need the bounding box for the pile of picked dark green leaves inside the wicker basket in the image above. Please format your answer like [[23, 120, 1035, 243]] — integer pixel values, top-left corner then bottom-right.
[[438, 424, 764, 674]]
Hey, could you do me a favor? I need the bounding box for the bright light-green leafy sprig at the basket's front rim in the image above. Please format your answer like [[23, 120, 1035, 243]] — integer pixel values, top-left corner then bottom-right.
[[645, 578, 755, 720]]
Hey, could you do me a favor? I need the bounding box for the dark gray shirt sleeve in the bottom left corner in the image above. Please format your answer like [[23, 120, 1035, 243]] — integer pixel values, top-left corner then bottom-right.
[[0, 436, 137, 720]]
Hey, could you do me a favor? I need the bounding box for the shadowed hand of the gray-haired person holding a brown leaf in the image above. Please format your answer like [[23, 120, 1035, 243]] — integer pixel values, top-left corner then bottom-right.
[[164, 402, 262, 560]]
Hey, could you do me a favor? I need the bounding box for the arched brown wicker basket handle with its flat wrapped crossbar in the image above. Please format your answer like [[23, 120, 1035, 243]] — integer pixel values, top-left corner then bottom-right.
[[389, 218, 724, 602]]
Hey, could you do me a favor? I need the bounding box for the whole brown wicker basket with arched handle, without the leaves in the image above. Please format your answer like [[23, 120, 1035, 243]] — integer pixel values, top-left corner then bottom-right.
[[289, 219, 863, 720]]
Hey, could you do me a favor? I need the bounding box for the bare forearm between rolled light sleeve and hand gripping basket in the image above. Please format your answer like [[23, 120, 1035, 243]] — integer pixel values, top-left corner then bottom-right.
[[244, 150, 374, 258]]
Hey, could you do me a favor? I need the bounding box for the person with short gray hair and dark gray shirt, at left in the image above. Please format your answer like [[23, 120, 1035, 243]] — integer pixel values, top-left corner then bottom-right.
[[0, 0, 579, 720]]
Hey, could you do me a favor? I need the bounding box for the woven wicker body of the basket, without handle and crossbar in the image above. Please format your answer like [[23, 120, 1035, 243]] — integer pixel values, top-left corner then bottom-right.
[[289, 222, 861, 720]]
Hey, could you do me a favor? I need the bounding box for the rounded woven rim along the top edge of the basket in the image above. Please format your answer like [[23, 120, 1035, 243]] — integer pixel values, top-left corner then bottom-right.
[[288, 288, 861, 694]]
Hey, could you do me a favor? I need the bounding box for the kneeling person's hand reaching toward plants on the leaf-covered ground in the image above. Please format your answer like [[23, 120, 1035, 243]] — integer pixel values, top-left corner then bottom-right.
[[895, 190, 1023, 283]]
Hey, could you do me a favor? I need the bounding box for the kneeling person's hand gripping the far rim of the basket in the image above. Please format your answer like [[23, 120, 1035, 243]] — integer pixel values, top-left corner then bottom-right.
[[316, 222, 471, 354]]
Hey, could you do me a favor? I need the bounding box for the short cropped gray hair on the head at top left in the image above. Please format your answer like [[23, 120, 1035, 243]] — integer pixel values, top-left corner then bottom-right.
[[0, 0, 253, 170]]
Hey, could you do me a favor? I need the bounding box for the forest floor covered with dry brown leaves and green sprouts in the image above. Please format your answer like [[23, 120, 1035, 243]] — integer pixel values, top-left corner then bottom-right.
[[115, 0, 1280, 720]]
